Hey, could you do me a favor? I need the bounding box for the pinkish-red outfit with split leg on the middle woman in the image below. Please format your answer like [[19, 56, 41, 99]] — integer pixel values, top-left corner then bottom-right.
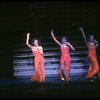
[[59, 46, 71, 76]]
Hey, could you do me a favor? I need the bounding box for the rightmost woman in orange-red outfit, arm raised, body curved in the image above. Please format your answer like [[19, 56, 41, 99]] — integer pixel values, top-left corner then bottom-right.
[[80, 27, 100, 81]]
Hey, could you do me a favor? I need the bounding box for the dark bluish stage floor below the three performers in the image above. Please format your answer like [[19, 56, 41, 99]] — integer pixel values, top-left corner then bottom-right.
[[0, 77, 100, 98]]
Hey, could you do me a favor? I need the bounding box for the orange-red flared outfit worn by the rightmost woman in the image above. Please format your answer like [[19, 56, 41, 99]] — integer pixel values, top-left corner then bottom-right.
[[87, 44, 99, 78]]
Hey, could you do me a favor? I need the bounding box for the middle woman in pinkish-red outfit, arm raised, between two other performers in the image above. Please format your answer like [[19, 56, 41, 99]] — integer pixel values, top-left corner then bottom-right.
[[51, 30, 75, 82]]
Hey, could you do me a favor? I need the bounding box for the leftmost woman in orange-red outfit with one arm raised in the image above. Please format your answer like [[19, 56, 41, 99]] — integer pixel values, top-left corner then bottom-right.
[[26, 33, 45, 83]]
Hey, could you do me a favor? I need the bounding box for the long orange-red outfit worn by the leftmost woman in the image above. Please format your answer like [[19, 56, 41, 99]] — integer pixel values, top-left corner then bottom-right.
[[31, 50, 45, 82]]
